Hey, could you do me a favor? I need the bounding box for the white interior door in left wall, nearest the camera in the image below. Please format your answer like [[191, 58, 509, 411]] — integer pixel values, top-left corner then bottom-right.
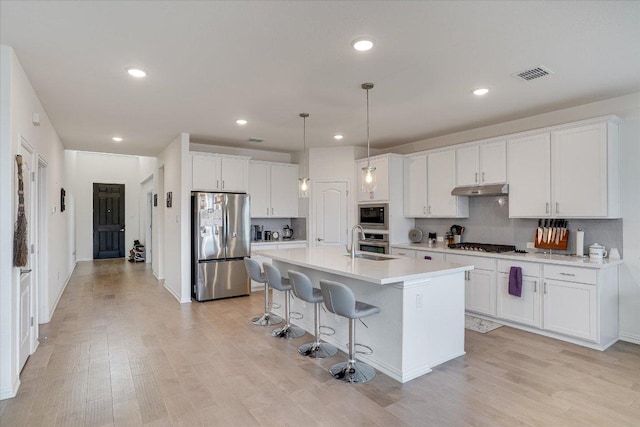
[[16, 140, 37, 370]]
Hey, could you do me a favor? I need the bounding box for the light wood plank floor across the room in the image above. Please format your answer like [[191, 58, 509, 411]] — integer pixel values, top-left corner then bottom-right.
[[0, 260, 640, 427]]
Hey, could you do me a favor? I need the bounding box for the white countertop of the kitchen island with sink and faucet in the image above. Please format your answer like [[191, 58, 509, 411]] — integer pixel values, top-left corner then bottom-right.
[[261, 247, 473, 285]]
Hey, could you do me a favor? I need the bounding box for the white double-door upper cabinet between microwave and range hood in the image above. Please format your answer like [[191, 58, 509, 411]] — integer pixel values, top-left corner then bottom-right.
[[404, 150, 469, 218]]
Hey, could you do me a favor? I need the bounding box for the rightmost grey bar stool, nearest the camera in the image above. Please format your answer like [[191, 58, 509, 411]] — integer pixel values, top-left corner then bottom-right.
[[320, 280, 380, 383]]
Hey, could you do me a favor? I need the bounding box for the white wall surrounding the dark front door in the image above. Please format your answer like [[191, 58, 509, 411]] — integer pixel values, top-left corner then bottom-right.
[[67, 150, 155, 261]]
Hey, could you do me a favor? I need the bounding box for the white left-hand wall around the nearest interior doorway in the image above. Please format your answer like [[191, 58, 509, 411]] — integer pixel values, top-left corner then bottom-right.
[[0, 46, 73, 399]]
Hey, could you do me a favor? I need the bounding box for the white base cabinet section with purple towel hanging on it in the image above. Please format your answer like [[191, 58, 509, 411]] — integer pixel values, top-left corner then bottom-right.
[[496, 260, 543, 328]]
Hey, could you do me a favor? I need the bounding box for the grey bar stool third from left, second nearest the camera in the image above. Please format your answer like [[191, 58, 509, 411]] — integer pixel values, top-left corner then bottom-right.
[[288, 270, 338, 359]]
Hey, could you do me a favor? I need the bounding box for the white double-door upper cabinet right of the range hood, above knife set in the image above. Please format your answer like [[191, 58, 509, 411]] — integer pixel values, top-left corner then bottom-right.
[[508, 121, 620, 218]]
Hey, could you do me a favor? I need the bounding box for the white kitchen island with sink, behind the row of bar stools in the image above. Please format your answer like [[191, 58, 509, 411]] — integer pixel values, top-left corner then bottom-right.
[[261, 247, 473, 383]]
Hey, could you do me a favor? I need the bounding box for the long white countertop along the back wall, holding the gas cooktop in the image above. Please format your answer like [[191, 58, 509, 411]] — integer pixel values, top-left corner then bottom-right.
[[391, 243, 623, 268]]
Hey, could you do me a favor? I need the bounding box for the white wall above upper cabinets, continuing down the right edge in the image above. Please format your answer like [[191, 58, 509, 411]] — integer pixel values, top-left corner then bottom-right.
[[388, 92, 640, 344]]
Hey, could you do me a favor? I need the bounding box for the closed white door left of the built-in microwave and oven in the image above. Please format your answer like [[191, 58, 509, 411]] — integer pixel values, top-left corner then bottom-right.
[[312, 181, 349, 247]]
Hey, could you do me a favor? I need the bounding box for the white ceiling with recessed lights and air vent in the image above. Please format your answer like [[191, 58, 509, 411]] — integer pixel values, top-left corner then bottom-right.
[[0, 0, 640, 155]]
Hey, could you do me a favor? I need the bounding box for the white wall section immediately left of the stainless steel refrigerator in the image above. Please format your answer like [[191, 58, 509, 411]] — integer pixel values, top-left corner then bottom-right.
[[154, 133, 191, 303]]
